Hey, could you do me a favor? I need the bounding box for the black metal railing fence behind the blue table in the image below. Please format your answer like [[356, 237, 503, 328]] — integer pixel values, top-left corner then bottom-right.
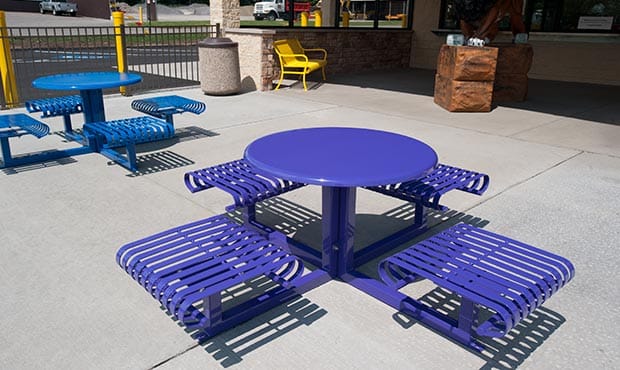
[[0, 25, 219, 107]]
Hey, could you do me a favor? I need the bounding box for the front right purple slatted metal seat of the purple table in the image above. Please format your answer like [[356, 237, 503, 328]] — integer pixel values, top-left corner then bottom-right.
[[379, 224, 575, 350]]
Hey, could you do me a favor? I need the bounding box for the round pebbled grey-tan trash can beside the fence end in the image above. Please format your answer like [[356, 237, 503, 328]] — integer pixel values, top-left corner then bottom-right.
[[198, 37, 241, 95]]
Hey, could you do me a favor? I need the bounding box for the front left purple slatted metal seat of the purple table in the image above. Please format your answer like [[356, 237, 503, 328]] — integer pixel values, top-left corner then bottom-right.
[[116, 215, 307, 336]]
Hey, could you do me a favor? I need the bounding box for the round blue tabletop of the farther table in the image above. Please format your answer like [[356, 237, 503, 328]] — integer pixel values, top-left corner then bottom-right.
[[32, 72, 142, 90]]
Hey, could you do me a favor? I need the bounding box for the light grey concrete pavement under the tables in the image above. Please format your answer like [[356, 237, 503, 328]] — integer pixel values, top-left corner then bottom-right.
[[0, 70, 620, 369]]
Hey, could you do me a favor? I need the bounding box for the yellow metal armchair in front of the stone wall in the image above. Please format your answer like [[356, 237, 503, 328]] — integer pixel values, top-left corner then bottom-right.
[[273, 39, 327, 91]]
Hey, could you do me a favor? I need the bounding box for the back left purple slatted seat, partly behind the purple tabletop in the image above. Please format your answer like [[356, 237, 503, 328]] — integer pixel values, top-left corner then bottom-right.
[[185, 159, 306, 211]]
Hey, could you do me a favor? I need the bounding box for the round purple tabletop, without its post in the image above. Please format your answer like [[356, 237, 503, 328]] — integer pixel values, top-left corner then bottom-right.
[[244, 127, 437, 187]]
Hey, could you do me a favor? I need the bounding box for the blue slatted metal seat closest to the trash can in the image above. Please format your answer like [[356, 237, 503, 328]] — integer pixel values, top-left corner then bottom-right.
[[131, 95, 207, 124]]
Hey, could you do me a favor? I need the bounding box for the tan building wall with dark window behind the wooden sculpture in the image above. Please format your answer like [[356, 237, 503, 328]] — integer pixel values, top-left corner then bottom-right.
[[410, 0, 620, 85]]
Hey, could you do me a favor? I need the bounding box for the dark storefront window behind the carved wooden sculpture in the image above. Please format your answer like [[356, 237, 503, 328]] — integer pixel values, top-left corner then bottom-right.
[[439, 0, 620, 33]]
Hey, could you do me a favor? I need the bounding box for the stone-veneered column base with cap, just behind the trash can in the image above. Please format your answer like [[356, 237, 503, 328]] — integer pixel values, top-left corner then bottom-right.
[[224, 28, 276, 91]]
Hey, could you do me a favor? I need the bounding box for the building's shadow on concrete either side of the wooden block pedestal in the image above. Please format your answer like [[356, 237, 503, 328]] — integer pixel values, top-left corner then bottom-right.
[[329, 68, 620, 125]]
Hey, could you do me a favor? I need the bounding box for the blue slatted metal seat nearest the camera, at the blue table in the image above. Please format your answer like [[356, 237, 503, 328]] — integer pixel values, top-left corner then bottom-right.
[[84, 116, 174, 171]]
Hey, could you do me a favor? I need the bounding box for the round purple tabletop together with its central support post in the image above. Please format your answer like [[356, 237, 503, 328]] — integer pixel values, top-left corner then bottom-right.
[[244, 127, 437, 277]]
